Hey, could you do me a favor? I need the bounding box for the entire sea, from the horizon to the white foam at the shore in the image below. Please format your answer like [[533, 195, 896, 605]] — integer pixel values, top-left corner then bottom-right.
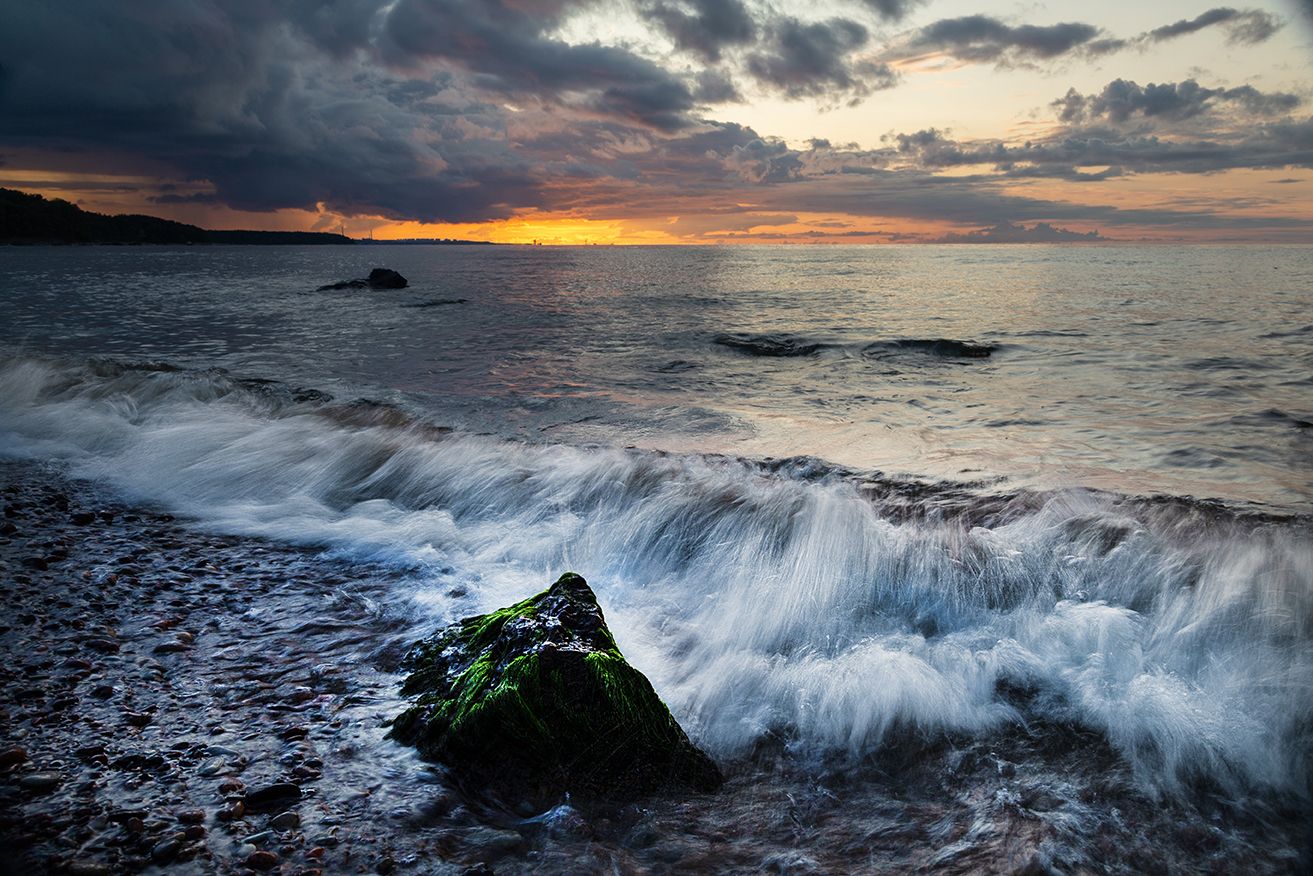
[[0, 247, 1313, 861]]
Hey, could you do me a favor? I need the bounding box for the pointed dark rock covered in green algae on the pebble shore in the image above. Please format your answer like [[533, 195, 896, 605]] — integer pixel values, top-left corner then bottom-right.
[[391, 574, 723, 799]]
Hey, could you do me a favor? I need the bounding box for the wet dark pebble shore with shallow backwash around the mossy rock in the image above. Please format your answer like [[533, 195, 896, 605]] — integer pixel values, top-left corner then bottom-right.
[[0, 462, 1309, 875]]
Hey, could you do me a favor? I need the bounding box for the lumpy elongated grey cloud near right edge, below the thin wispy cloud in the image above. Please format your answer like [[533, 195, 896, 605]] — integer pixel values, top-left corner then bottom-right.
[[1053, 79, 1302, 123]]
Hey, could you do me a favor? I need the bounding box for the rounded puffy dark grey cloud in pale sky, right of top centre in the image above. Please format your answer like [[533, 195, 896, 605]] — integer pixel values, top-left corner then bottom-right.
[[747, 18, 897, 101]]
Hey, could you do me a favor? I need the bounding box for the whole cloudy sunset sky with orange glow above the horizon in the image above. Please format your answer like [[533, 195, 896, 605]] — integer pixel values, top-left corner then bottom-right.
[[0, 0, 1313, 244]]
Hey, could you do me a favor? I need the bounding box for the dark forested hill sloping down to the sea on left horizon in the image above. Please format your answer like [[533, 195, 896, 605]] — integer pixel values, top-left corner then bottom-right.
[[0, 189, 355, 244]]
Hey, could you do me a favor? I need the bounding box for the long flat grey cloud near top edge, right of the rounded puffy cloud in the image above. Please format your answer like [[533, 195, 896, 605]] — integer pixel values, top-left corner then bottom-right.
[[909, 14, 1100, 64]]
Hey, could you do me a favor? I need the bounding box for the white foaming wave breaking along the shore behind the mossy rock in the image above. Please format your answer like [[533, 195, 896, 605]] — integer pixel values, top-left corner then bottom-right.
[[0, 356, 1313, 793]]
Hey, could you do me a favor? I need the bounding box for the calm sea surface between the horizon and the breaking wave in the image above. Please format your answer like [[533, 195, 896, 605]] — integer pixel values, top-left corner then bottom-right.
[[0, 246, 1313, 511]]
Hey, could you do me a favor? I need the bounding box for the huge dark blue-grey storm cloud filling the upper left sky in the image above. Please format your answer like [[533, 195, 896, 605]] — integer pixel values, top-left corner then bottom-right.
[[0, 0, 723, 221]]
